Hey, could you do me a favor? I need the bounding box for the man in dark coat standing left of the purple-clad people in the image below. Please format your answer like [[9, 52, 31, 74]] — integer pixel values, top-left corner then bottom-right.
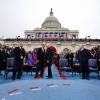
[[12, 43, 25, 80]]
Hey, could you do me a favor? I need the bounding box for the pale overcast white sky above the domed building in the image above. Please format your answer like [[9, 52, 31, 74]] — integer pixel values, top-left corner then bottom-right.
[[0, 0, 100, 39]]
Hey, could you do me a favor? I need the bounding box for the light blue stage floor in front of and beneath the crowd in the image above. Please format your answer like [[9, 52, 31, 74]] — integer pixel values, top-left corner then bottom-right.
[[0, 66, 100, 100]]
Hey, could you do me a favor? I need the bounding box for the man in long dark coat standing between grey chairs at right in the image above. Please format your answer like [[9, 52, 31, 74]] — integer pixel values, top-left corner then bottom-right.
[[77, 44, 91, 79]]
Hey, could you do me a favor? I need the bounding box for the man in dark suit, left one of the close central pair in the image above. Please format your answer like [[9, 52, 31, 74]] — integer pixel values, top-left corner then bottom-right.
[[35, 42, 46, 78]]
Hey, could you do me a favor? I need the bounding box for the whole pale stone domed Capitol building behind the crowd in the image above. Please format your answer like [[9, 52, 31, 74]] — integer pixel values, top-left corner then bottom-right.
[[1, 8, 100, 53]]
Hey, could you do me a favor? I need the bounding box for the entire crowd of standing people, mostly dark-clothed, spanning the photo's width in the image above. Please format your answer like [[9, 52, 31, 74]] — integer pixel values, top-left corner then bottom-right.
[[0, 43, 100, 80]]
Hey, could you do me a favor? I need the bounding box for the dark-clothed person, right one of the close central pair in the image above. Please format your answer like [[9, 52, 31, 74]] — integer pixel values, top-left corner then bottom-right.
[[46, 45, 54, 78]]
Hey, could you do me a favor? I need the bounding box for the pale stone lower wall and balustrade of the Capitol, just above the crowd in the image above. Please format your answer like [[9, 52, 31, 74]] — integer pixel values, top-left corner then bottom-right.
[[2, 39, 100, 53]]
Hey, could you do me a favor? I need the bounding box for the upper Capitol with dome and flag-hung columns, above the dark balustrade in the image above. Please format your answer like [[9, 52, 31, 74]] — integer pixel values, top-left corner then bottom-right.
[[24, 8, 79, 40]]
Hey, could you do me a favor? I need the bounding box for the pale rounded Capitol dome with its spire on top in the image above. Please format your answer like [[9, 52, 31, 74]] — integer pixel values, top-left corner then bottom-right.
[[42, 8, 61, 28]]
